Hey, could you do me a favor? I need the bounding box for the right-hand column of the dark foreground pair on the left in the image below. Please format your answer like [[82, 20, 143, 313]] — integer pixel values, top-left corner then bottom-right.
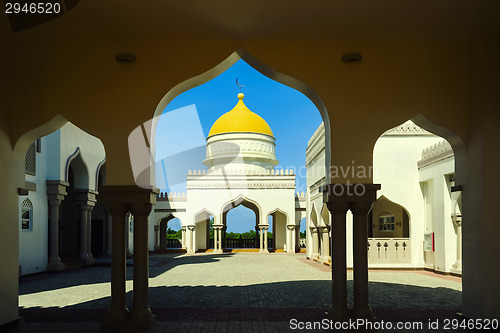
[[131, 200, 156, 328]]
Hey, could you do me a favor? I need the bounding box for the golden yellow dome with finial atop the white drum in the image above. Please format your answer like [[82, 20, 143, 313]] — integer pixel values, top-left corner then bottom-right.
[[208, 93, 274, 137]]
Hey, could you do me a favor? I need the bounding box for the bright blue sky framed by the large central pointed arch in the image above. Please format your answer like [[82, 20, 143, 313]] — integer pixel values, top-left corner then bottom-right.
[[156, 60, 322, 232]]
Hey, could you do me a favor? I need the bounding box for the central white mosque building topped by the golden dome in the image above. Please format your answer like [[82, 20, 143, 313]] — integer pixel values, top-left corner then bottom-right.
[[150, 93, 305, 253]]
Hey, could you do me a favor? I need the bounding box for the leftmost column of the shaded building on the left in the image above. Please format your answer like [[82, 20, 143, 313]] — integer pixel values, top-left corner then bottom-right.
[[47, 180, 69, 272]]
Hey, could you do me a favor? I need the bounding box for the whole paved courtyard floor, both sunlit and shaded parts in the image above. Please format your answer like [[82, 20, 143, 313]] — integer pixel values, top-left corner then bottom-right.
[[14, 253, 463, 332]]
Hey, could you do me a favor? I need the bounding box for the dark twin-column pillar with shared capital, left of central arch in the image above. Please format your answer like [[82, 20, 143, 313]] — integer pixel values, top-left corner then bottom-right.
[[101, 186, 157, 329]]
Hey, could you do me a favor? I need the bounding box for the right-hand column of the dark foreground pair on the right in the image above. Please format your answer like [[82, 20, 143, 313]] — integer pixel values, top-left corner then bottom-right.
[[351, 198, 375, 319]]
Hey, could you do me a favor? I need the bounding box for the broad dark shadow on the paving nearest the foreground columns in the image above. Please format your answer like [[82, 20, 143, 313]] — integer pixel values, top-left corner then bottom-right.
[[20, 280, 461, 331]]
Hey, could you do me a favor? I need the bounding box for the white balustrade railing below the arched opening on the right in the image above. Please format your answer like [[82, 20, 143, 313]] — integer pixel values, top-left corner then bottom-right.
[[368, 238, 411, 264]]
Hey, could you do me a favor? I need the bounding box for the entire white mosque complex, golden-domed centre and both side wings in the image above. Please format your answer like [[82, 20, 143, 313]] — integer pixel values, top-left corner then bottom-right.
[[19, 93, 461, 275]]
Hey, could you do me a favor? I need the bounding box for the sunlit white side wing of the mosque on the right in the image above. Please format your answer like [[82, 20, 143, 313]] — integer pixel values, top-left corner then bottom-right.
[[306, 121, 462, 275]]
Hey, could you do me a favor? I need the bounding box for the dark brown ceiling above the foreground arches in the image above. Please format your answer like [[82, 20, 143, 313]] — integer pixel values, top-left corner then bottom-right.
[[0, 0, 500, 41]]
